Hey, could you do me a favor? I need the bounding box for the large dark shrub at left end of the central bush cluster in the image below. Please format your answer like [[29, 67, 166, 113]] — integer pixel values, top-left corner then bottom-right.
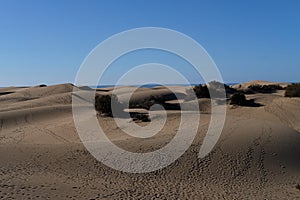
[[95, 95, 122, 116]]
